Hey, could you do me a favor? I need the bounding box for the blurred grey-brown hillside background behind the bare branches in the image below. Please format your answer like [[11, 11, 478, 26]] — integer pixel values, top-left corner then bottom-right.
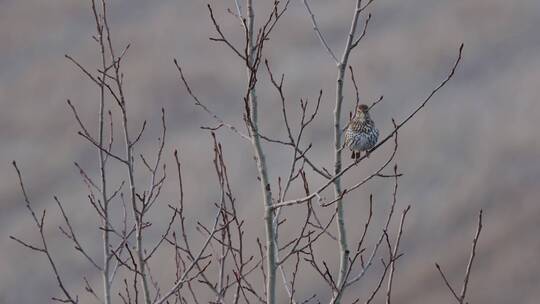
[[0, 0, 540, 304]]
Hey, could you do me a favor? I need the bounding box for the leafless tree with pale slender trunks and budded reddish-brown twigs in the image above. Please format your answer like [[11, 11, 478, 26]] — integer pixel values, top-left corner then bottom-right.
[[12, 0, 481, 304]]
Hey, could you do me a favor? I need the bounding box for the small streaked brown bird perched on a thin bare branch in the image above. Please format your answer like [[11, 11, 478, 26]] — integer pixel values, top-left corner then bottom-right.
[[343, 104, 379, 159]]
